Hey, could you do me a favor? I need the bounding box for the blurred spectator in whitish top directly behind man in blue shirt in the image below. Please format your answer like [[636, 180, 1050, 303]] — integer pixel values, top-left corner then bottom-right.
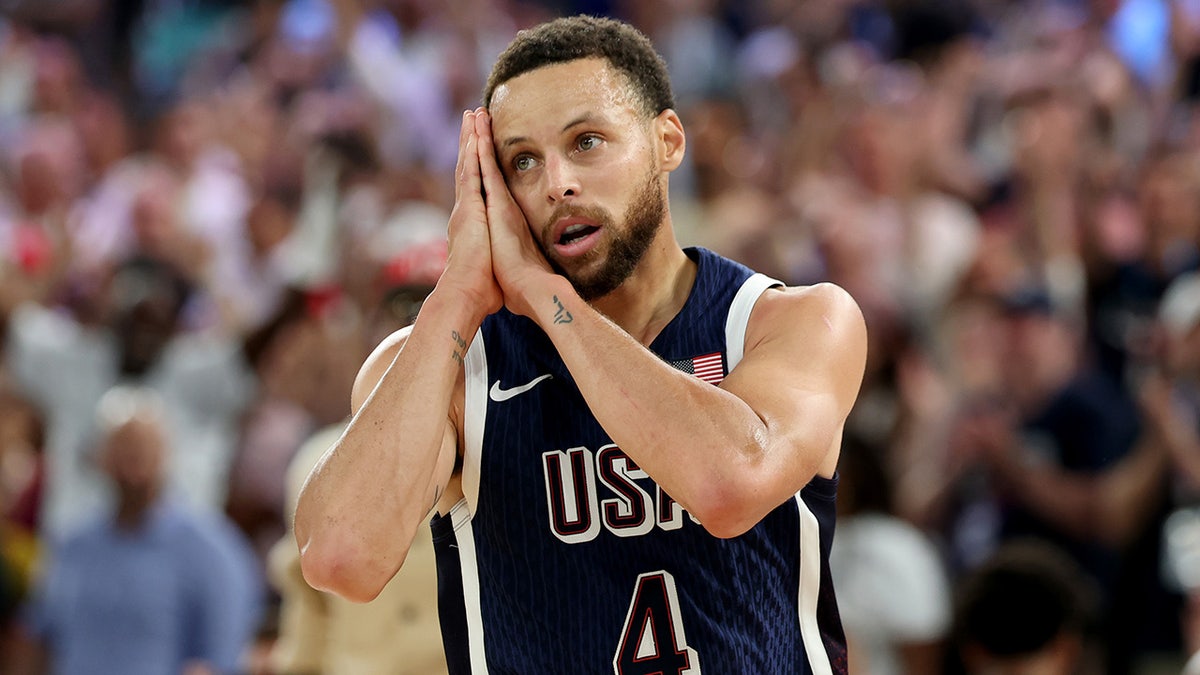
[[5, 252, 254, 534]]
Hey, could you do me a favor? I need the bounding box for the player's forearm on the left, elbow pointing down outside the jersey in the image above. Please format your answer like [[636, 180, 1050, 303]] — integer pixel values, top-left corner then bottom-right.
[[295, 288, 482, 599]]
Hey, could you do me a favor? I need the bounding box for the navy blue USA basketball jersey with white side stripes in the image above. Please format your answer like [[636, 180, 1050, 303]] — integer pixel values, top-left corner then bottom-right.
[[433, 249, 846, 675]]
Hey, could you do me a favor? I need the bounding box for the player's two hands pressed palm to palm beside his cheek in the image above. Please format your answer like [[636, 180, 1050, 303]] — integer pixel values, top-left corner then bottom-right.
[[439, 108, 554, 316]]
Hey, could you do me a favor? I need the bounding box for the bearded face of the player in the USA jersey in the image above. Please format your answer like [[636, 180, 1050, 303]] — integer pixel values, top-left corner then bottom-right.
[[490, 59, 666, 300]]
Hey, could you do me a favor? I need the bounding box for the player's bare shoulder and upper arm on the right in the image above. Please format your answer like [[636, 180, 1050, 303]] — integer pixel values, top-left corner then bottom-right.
[[722, 283, 866, 478]]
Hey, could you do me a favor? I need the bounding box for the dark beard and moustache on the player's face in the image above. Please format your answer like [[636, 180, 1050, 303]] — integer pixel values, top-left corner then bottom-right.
[[539, 165, 667, 301]]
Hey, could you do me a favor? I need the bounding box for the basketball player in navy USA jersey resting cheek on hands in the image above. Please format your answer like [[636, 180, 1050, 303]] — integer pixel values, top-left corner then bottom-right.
[[295, 17, 866, 674]]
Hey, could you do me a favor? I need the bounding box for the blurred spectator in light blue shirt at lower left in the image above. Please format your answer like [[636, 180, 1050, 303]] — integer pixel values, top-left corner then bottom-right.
[[2, 387, 262, 675]]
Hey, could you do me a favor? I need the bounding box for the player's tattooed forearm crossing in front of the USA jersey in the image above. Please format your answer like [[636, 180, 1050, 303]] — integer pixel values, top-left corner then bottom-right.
[[529, 277, 828, 534]]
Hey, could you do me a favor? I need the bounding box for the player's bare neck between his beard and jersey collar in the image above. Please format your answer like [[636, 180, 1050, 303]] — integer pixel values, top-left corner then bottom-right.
[[592, 225, 696, 345]]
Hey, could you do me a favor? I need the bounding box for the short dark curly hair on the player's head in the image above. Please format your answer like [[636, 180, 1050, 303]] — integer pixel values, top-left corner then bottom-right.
[[484, 14, 674, 117]]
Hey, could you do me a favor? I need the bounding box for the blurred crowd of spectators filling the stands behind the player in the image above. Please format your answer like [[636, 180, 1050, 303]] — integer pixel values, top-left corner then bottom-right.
[[0, 0, 1200, 675]]
